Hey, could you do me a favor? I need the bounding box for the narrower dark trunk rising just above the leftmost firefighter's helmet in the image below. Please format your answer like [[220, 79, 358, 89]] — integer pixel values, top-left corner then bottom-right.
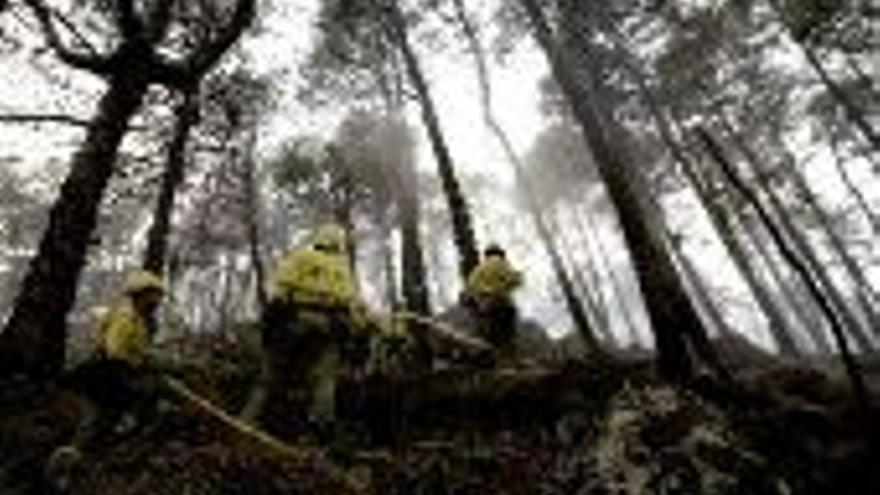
[[143, 88, 199, 273]]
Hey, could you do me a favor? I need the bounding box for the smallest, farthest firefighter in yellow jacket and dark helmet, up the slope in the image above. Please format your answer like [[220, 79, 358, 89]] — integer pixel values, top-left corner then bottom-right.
[[463, 244, 522, 359]]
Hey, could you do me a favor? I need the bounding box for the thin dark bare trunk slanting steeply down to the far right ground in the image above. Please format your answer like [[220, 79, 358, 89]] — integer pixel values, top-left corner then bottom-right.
[[697, 128, 871, 418]]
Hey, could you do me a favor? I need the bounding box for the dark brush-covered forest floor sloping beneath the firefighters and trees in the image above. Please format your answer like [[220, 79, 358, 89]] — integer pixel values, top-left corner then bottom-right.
[[0, 341, 880, 495]]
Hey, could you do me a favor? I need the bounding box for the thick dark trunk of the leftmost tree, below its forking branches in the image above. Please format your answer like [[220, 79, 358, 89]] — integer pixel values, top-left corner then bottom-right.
[[0, 73, 148, 376]]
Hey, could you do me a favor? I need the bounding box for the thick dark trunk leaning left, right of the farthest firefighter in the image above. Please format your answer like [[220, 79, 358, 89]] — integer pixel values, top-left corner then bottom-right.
[[520, 0, 726, 381]]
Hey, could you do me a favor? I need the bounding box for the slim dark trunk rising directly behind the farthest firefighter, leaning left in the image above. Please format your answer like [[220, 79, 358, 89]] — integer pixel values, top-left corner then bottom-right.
[[382, 0, 479, 280]]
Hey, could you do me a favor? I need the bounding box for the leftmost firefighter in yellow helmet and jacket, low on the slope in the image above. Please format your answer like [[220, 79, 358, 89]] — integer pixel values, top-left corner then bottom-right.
[[47, 270, 165, 477]]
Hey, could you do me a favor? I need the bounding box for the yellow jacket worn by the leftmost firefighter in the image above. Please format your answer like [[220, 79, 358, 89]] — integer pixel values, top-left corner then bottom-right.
[[98, 298, 150, 366]]
